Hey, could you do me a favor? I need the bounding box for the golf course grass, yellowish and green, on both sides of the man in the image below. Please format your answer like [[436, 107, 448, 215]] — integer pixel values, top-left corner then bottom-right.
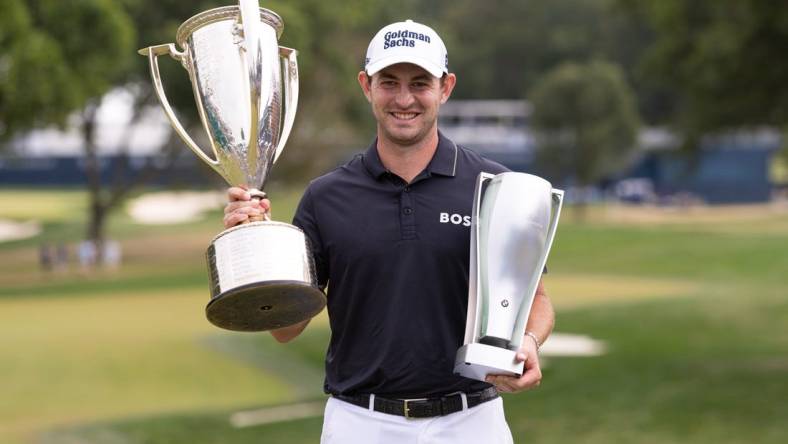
[[0, 188, 788, 444]]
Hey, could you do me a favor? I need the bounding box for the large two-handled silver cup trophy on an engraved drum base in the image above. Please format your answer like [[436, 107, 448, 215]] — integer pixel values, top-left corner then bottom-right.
[[139, 0, 326, 331]]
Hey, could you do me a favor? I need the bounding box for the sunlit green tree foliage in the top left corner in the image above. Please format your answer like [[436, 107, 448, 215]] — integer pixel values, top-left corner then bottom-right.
[[0, 0, 134, 140]]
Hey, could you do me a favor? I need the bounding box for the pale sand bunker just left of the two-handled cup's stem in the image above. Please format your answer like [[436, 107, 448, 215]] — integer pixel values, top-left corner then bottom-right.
[[127, 191, 227, 225]]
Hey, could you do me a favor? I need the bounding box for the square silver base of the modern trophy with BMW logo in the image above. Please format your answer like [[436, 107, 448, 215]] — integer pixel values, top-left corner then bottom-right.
[[454, 342, 525, 381]]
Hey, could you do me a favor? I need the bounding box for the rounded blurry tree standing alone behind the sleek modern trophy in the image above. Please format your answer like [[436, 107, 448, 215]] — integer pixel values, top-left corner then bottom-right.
[[531, 61, 639, 212]]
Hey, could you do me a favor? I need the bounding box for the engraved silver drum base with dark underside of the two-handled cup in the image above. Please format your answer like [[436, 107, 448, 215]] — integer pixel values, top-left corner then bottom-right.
[[205, 222, 326, 331]]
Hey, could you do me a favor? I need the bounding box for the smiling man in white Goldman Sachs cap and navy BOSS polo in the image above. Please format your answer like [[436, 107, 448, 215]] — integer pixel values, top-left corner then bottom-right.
[[224, 20, 553, 444]]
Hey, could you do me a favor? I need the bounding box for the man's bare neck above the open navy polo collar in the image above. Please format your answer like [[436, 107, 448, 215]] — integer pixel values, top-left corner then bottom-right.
[[377, 128, 439, 183]]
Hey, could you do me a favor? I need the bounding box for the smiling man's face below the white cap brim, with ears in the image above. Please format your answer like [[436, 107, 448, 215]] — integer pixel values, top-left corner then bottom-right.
[[358, 63, 456, 146]]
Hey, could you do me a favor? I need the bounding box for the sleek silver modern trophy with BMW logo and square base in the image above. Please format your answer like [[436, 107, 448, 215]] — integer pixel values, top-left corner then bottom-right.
[[454, 173, 564, 381]]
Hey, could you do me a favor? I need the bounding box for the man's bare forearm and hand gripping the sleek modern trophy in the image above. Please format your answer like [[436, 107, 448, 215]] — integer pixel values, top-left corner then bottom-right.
[[487, 280, 555, 393]]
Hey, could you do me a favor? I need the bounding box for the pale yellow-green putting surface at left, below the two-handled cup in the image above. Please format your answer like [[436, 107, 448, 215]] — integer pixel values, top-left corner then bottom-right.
[[0, 287, 292, 442]]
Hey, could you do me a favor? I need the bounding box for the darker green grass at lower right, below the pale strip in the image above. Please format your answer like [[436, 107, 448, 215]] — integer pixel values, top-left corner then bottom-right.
[[507, 287, 788, 443]]
